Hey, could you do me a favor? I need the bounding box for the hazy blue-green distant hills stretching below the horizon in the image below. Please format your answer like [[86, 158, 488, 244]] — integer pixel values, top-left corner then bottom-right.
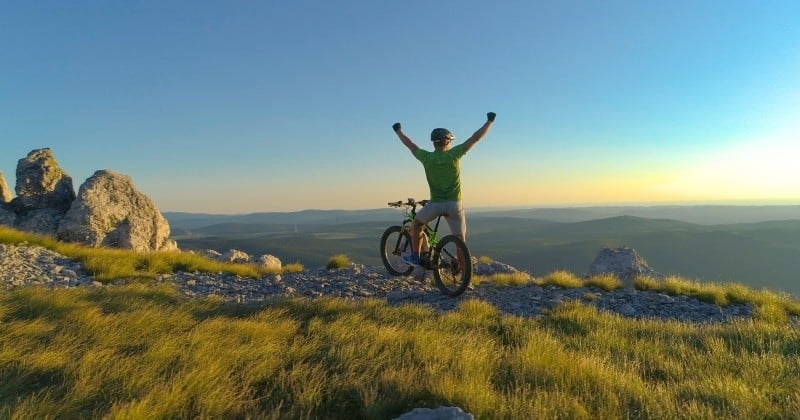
[[165, 206, 800, 296]]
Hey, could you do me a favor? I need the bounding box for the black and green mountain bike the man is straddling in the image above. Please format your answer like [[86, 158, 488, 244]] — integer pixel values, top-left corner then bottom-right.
[[381, 198, 472, 296]]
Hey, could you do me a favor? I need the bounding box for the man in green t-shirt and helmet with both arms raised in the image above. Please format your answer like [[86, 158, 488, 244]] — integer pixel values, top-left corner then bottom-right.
[[392, 112, 495, 266]]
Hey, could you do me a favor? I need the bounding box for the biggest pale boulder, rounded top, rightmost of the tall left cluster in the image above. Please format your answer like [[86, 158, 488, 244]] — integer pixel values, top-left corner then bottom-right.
[[58, 170, 178, 252]]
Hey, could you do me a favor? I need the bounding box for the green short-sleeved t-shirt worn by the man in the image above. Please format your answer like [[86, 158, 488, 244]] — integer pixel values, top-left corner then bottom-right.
[[414, 143, 467, 203]]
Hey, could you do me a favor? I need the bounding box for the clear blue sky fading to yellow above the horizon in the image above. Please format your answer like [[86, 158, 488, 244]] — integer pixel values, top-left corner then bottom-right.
[[0, 0, 800, 213]]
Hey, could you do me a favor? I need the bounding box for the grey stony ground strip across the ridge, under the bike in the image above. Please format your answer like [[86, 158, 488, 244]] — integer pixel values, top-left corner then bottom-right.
[[0, 244, 752, 323]]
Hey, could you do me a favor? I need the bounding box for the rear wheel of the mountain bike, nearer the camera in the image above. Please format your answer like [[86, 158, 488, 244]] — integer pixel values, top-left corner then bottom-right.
[[431, 235, 472, 296]]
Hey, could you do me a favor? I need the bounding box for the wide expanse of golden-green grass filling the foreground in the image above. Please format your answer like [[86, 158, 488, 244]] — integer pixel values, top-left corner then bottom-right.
[[0, 284, 800, 419]]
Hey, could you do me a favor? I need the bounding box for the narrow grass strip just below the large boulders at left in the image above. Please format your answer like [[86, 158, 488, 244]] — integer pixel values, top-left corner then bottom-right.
[[0, 225, 303, 282]]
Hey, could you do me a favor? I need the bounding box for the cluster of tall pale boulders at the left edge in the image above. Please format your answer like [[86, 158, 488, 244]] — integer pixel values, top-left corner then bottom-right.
[[0, 148, 178, 252]]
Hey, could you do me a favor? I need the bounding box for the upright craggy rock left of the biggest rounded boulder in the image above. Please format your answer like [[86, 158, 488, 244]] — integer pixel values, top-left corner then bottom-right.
[[11, 148, 75, 215]]
